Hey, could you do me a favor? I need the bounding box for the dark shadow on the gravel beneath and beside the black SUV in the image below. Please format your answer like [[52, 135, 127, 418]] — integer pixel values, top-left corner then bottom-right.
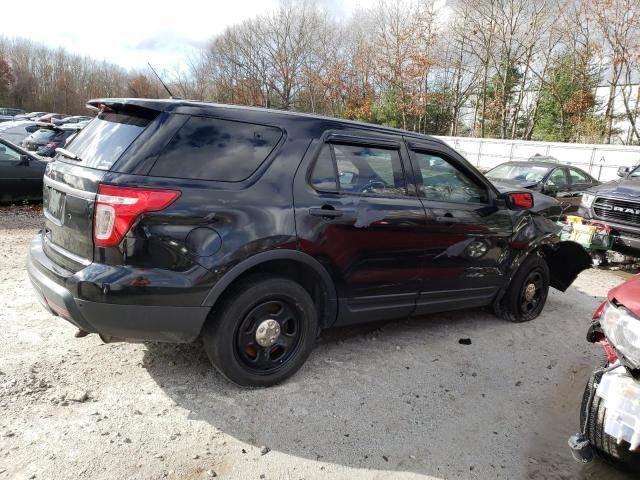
[[144, 300, 636, 478]]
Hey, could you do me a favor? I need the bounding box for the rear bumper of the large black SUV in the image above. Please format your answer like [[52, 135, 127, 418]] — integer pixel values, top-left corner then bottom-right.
[[27, 235, 209, 343]]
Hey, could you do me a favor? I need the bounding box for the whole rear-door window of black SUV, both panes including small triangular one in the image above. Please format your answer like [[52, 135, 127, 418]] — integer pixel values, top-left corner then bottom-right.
[[311, 144, 407, 195]]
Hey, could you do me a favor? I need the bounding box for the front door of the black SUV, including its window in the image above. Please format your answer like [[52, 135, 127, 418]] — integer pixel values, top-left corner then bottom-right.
[[408, 141, 513, 313]]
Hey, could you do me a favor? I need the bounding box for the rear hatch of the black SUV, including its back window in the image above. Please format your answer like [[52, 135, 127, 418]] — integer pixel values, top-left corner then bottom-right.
[[43, 105, 159, 272]]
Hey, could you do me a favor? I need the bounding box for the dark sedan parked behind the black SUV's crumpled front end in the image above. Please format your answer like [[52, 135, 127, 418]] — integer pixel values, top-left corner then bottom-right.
[[485, 157, 600, 213]]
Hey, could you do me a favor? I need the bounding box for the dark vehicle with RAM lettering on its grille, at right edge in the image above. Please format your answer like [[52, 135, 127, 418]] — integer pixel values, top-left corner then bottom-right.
[[578, 165, 640, 257]]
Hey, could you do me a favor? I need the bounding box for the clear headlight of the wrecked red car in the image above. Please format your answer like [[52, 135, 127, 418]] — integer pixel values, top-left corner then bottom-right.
[[600, 302, 640, 368]]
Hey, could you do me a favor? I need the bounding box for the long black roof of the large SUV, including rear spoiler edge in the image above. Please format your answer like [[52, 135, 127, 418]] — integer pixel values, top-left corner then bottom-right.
[[87, 98, 445, 145]]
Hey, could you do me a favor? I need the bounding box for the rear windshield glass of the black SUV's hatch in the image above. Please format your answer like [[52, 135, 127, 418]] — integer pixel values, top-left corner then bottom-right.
[[62, 113, 151, 170]]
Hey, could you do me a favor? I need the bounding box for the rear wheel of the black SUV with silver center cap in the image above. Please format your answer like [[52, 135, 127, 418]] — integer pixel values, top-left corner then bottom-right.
[[203, 276, 318, 387]]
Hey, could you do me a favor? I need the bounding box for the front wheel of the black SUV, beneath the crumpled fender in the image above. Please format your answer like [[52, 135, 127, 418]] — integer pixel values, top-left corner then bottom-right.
[[496, 255, 549, 323]]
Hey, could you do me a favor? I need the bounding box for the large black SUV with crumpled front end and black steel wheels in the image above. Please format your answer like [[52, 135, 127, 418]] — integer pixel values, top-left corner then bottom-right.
[[28, 99, 591, 386]]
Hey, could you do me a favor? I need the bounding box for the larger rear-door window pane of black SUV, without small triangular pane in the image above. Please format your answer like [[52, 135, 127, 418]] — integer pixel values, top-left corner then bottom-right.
[[333, 145, 406, 195]]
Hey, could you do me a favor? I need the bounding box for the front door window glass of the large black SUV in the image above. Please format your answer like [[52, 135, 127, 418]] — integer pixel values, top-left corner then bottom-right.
[[415, 153, 487, 203]]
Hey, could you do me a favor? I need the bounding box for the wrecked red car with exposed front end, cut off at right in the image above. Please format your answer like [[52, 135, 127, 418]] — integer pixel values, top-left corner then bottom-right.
[[569, 275, 640, 472]]
